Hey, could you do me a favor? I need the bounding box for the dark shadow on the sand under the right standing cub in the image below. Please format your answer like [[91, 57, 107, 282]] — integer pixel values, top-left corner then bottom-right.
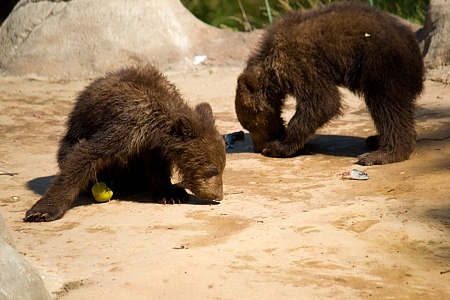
[[227, 133, 370, 158]]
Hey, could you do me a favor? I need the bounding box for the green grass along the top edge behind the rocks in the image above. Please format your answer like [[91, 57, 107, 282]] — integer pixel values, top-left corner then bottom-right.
[[181, 0, 430, 31]]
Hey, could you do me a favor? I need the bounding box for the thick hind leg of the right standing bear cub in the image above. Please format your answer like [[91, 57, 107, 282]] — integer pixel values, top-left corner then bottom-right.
[[358, 95, 416, 166]]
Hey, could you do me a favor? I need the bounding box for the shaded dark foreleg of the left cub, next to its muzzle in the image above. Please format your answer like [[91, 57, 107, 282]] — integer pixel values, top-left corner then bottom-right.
[[144, 149, 189, 204]]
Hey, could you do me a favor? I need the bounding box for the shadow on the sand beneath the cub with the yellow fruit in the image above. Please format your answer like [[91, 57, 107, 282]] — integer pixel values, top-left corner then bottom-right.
[[27, 175, 220, 208]]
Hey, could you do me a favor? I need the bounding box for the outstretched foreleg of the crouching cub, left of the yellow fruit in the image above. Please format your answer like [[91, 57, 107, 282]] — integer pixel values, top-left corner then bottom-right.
[[24, 141, 108, 222]]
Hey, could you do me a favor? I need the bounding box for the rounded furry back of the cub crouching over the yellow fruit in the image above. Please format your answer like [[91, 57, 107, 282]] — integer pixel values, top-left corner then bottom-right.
[[64, 65, 187, 139]]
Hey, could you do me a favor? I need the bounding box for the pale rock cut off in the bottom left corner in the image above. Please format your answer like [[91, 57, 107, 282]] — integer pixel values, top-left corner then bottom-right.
[[0, 215, 51, 300]]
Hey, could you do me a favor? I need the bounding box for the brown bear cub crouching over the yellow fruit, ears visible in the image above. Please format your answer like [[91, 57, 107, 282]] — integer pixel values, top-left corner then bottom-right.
[[25, 66, 225, 222]]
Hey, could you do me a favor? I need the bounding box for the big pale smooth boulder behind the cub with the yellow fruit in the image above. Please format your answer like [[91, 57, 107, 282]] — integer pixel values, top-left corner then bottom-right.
[[0, 0, 258, 77]]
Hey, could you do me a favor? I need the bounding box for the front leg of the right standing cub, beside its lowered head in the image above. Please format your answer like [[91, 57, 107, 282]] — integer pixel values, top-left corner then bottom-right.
[[262, 84, 341, 157]]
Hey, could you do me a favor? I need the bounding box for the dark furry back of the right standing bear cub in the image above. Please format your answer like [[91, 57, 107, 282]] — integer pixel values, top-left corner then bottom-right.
[[256, 2, 424, 93]]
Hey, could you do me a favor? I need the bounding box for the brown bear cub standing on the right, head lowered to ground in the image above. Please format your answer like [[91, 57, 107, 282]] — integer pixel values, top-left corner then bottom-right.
[[235, 2, 424, 165]]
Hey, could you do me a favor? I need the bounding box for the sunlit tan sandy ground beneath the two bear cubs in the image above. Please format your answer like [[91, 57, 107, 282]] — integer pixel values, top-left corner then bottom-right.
[[0, 69, 450, 300]]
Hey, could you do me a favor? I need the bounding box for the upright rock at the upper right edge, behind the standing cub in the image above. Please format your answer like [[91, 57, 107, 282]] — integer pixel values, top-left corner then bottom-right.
[[418, 0, 450, 81]]
